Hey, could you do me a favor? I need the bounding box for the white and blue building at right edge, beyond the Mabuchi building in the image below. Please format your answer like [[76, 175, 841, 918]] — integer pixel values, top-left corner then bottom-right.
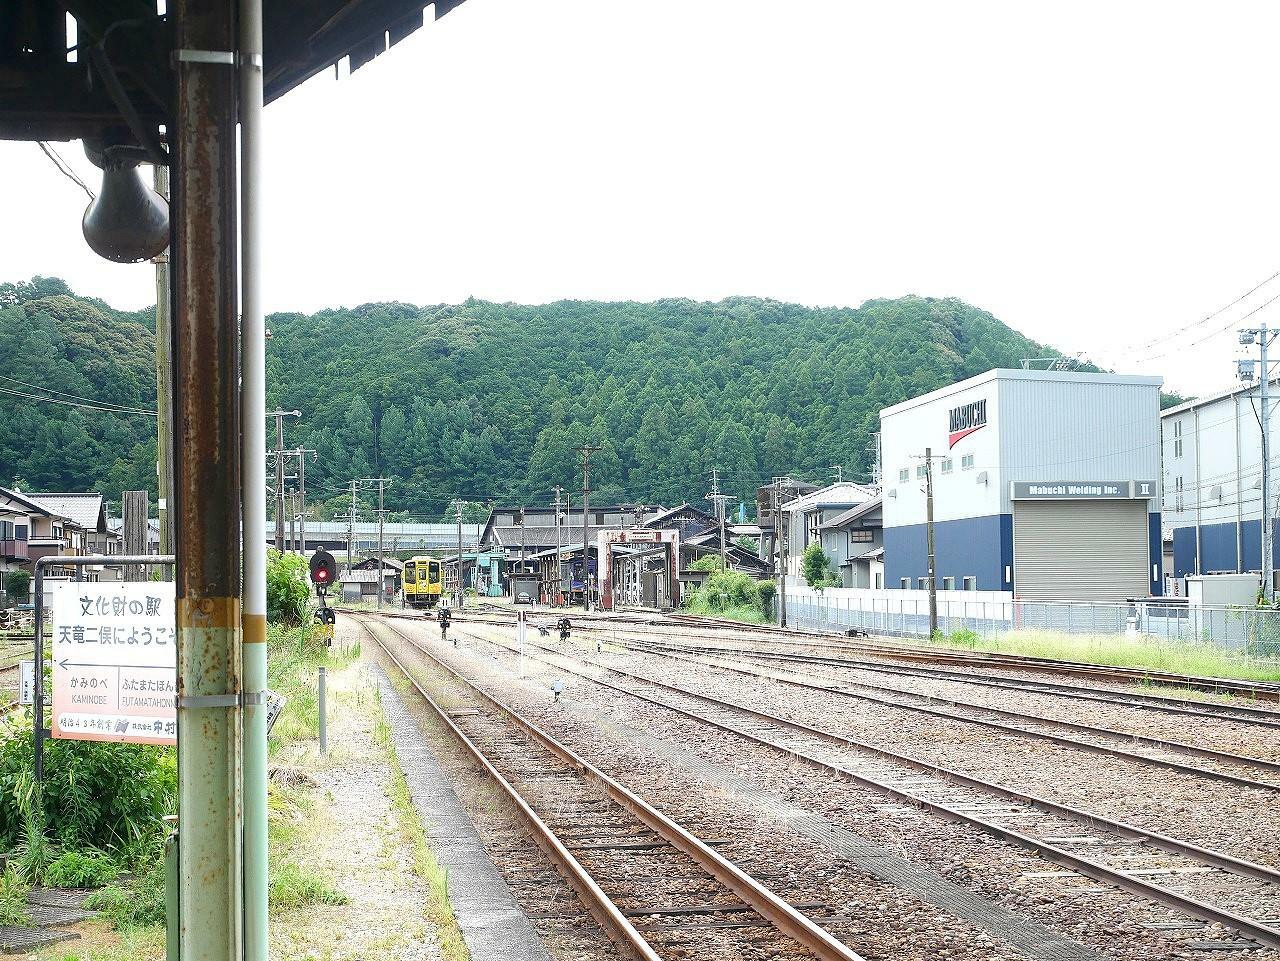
[[1160, 383, 1277, 578]]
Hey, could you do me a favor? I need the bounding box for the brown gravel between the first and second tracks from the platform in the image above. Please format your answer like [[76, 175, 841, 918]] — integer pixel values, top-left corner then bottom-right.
[[398, 624, 1271, 957]]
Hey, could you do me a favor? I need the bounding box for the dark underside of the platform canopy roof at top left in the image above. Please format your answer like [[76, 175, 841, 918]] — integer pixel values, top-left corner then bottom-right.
[[0, 0, 463, 147]]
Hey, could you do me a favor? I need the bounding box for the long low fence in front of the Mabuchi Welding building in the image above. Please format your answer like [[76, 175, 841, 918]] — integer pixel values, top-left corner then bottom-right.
[[787, 591, 1280, 658]]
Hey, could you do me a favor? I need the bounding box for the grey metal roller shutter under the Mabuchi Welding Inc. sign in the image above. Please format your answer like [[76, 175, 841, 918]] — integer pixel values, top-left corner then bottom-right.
[[1014, 500, 1151, 601]]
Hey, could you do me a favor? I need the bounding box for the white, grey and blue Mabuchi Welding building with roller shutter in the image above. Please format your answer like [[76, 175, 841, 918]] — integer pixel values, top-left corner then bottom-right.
[[881, 370, 1162, 601]]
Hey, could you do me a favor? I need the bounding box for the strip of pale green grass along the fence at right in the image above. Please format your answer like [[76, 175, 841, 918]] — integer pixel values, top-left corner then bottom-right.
[[932, 631, 1280, 681]]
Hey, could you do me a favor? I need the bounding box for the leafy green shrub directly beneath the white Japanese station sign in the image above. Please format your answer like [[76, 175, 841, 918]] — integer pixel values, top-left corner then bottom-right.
[[0, 722, 178, 854]]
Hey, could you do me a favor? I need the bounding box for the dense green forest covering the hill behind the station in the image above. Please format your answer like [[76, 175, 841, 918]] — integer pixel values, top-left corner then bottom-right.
[[0, 278, 1090, 518]]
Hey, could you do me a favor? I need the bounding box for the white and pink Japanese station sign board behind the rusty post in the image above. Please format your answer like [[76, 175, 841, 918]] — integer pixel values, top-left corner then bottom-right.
[[50, 581, 178, 743]]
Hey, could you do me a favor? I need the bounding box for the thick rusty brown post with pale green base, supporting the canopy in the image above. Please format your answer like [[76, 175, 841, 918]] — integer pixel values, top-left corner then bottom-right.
[[169, 0, 241, 961]]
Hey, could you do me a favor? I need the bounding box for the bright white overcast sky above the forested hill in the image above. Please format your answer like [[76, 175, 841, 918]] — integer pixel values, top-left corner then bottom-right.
[[0, 0, 1280, 394]]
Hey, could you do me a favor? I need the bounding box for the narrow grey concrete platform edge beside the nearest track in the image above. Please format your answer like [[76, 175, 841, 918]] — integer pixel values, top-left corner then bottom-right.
[[370, 664, 550, 961]]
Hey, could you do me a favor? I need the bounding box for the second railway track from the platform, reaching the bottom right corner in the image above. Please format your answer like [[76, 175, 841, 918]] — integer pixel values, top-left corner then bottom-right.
[[396, 616, 1280, 947]]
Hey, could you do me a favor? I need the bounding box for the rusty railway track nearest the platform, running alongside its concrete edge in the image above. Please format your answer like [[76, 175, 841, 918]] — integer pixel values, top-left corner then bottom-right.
[[355, 616, 861, 961]]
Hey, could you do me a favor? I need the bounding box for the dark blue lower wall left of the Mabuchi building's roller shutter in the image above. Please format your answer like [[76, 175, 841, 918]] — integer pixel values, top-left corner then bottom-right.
[[884, 514, 1014, 591]]
